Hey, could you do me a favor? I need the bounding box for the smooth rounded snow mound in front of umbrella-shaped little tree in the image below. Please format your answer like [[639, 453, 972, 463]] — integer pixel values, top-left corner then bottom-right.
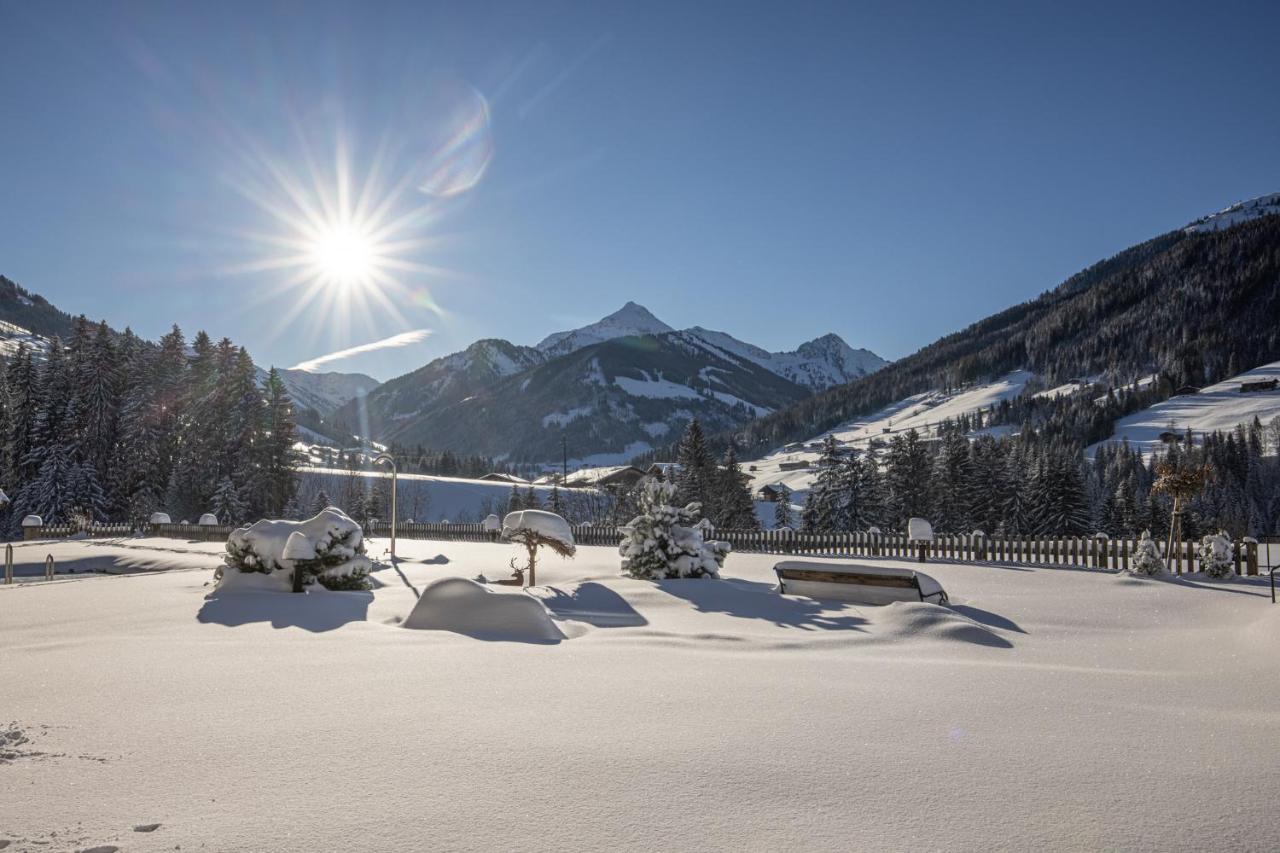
[[403, 578, 564, 643]]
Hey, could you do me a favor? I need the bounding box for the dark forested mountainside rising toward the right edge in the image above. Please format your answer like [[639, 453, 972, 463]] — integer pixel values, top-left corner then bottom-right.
[[716, 196, 1280, 455]]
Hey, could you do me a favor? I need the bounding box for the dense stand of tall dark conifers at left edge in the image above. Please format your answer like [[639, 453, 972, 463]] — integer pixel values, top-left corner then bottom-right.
[[0, 316, 300, 534]]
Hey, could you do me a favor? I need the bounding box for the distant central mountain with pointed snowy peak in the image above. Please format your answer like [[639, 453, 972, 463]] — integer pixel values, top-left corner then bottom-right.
[[338, 302, 886, 464]]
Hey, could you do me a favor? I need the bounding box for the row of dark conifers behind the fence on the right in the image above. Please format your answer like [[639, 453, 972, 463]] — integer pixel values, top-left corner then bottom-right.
[[798, 418, 1280, 537]]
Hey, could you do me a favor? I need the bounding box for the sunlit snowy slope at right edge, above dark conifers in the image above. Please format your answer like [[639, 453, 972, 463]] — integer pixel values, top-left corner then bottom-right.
[[1085, 361, 1280, 457]]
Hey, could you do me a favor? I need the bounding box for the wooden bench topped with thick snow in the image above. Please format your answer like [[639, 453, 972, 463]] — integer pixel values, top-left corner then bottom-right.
[[773, 560, 947, 605]]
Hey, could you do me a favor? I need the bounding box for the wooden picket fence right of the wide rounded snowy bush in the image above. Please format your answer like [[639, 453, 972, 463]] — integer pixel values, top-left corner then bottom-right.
[[369, 521, 1258, 575]]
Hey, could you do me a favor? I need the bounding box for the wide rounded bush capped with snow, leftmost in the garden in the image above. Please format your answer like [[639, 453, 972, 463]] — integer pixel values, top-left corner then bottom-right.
[[220, 507, 372, 589]]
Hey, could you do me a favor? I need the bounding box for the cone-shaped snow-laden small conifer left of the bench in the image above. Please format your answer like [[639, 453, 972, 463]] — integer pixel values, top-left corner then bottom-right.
[[618, 479, 730, 580]]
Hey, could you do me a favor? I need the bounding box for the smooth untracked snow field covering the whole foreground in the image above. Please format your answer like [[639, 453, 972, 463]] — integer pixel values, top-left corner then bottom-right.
[[0, 539, 1280, 852]]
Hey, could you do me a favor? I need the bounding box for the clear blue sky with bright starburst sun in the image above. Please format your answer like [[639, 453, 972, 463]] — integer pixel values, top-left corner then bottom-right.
[[0, 0, 1280, 379]]
